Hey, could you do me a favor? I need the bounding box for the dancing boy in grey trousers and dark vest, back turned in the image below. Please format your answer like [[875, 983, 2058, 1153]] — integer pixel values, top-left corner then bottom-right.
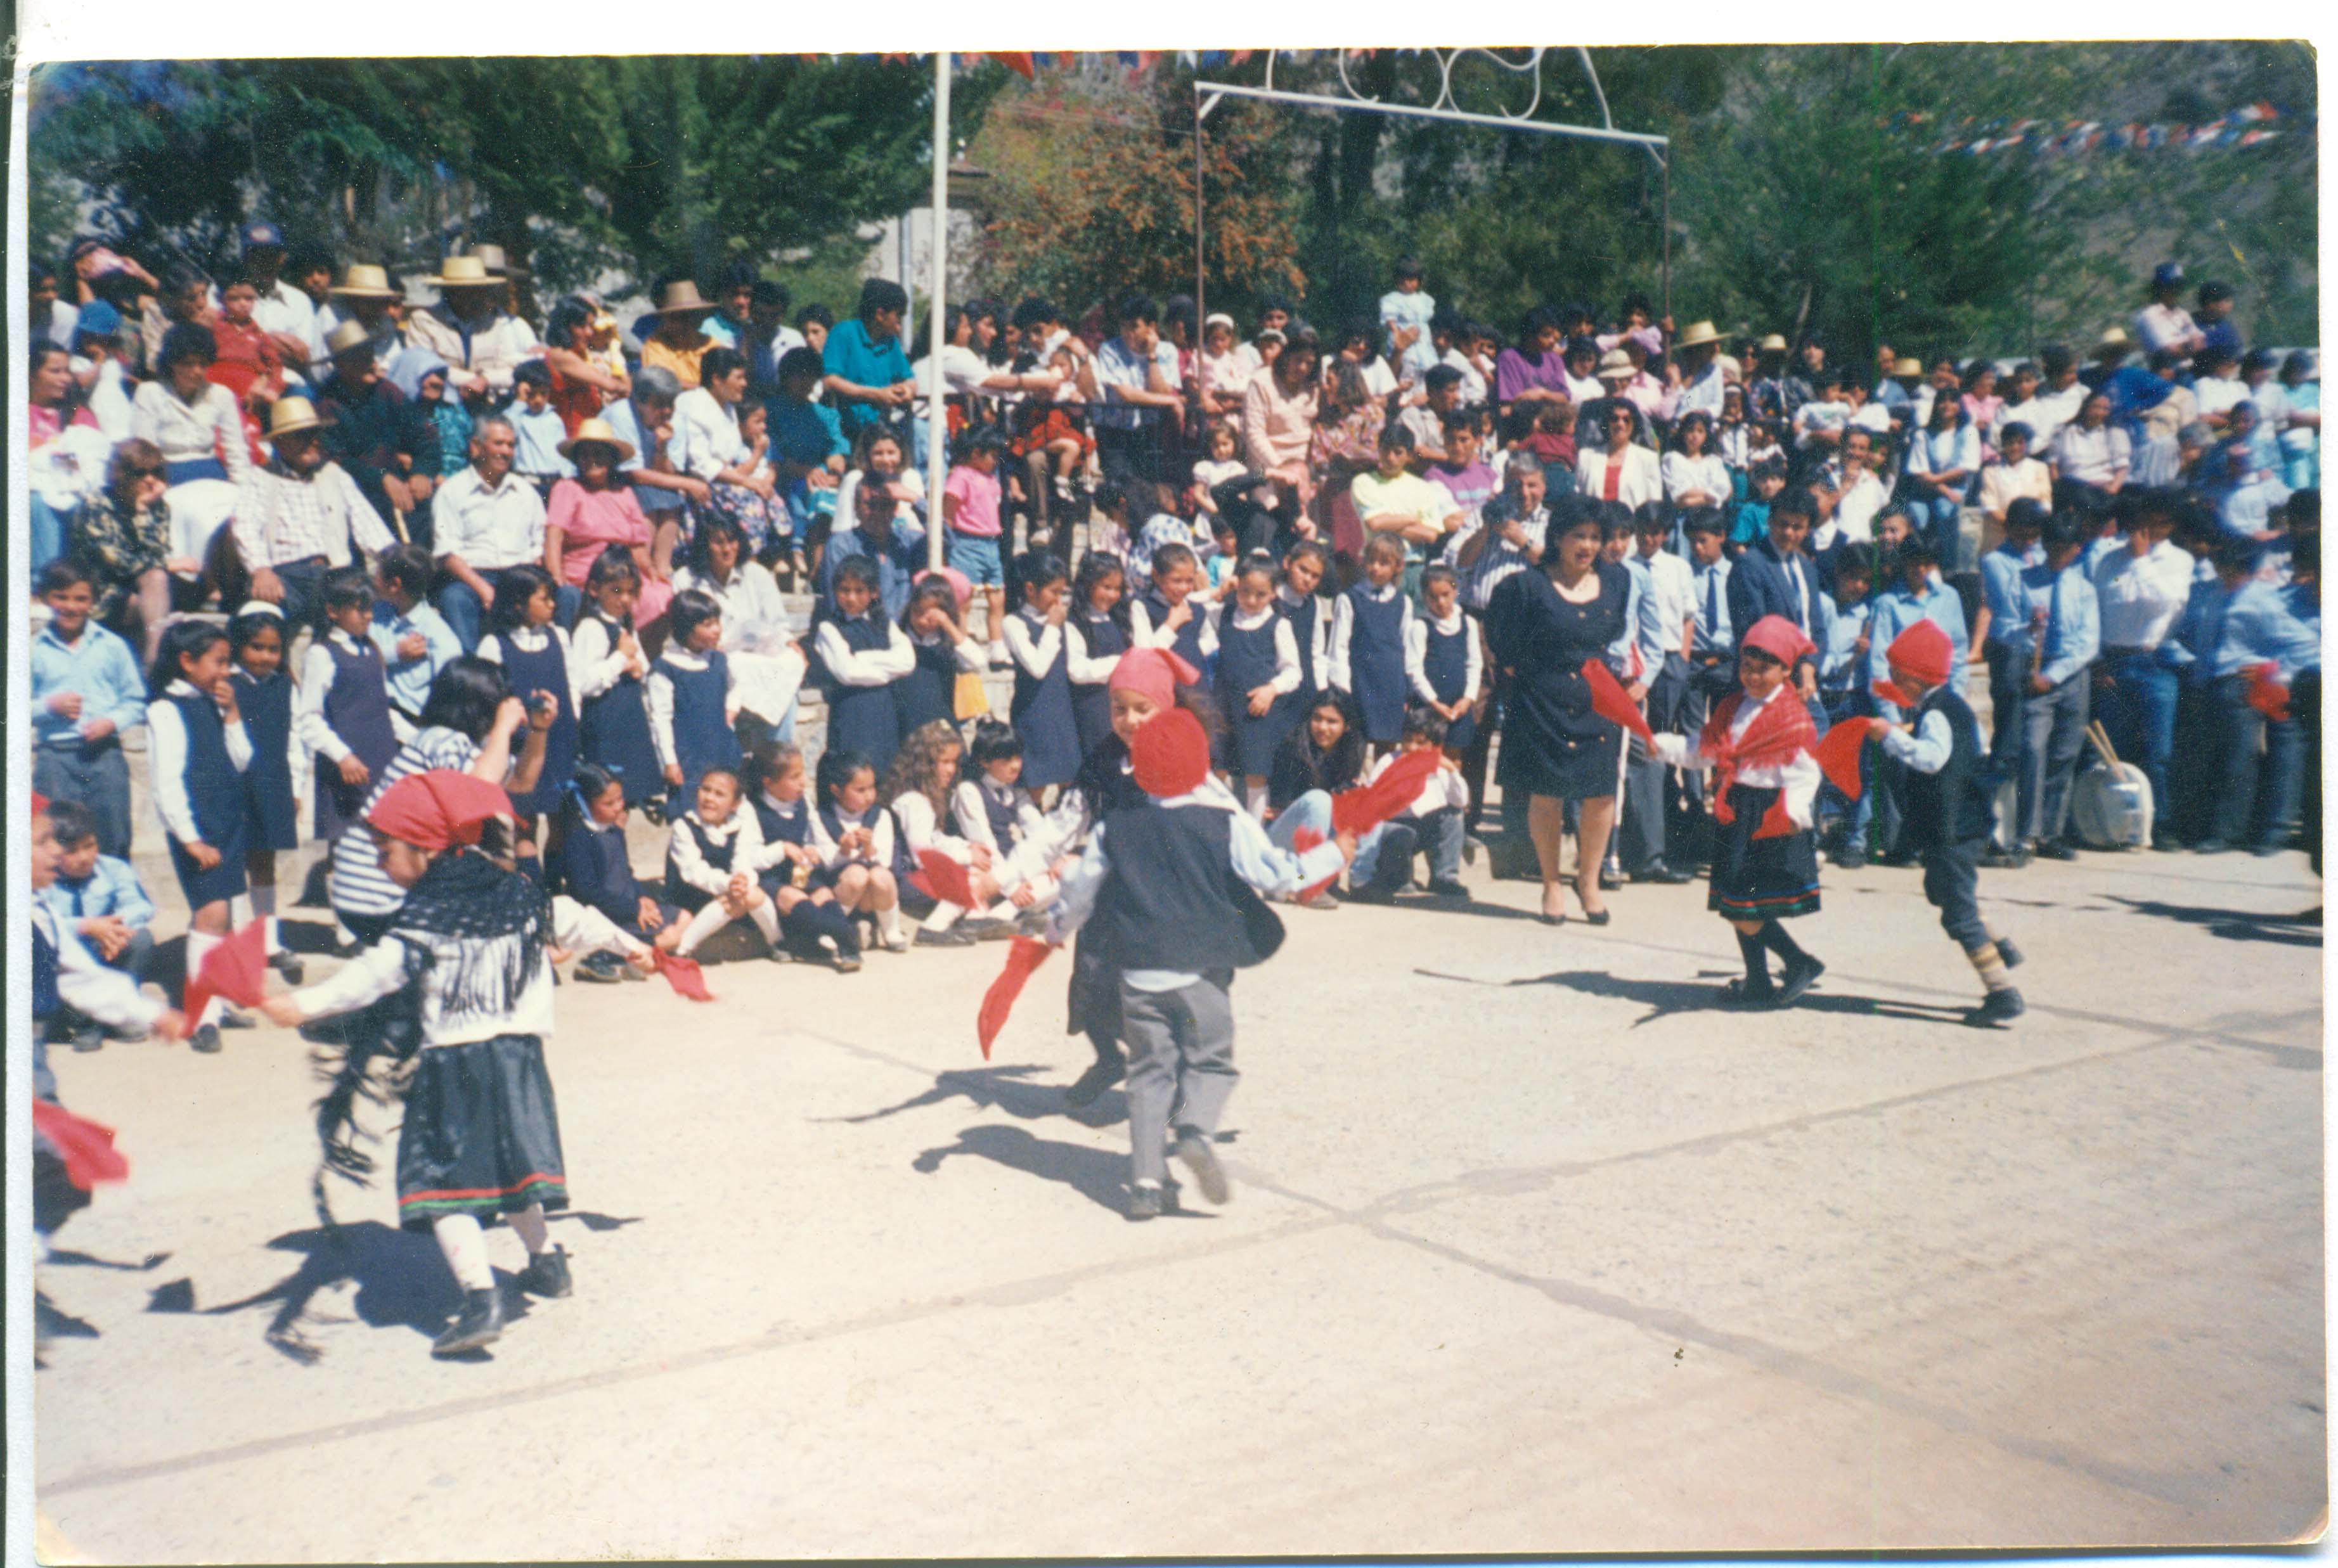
[[1047, 708, 1356, 1220]]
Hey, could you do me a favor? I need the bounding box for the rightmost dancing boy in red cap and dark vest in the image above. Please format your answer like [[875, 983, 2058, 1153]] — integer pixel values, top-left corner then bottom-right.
[[1868, 622, 2022, 1028]]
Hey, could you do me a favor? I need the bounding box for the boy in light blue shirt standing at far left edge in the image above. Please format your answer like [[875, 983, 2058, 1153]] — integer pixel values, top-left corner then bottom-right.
[[33, 558, 147, 855]]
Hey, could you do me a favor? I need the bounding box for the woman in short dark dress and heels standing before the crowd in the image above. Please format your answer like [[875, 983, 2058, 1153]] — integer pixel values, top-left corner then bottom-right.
[[1485, 498, 1632, 925]]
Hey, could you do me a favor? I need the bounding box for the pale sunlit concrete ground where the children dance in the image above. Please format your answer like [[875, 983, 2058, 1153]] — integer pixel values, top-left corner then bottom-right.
[[35, 818, 2327, 1561]]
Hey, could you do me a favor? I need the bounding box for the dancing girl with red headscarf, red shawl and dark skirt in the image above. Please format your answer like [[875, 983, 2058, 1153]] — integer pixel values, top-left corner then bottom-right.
[[1655, 615, 1826, 1007]]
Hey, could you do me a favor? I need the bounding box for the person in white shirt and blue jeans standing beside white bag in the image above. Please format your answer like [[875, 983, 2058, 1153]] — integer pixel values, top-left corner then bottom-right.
[[2095, 491, 2193, 848]]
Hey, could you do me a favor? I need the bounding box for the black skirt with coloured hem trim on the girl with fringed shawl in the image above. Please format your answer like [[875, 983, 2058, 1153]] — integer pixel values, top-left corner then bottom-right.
[[397, 1035, 568, 1231]]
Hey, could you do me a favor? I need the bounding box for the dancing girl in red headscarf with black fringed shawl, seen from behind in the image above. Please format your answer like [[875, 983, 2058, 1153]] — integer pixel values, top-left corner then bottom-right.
[[259, 769, 655, 1355]]
